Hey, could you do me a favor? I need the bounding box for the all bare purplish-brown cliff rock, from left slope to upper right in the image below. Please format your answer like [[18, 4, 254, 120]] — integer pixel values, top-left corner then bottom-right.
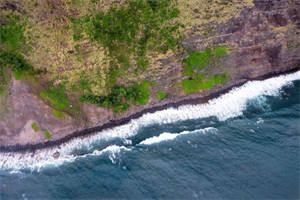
[[0, 0, 300, 149]]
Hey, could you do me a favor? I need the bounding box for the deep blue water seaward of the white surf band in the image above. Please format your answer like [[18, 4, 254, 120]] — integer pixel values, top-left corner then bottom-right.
[[0, 81, 300, 200]]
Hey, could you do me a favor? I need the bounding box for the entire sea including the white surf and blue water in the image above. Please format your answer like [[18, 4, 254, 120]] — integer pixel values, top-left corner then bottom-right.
[[0, 72, 300, 200]]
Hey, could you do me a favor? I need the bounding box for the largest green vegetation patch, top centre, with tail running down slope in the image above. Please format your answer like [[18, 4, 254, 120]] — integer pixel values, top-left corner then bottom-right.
[[71, 0, 181, 89]]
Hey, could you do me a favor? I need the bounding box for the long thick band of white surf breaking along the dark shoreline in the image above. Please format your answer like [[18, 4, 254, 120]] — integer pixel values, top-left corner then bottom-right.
[[0, 71, 300, 170]]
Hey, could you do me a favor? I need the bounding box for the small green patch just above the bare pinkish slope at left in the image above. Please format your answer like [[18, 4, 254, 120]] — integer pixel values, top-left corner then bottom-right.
[[40, 84, 70, 109]]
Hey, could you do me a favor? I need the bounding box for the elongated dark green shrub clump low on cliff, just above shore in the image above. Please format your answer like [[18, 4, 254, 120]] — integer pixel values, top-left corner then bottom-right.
[[79, 80, 151, 112]]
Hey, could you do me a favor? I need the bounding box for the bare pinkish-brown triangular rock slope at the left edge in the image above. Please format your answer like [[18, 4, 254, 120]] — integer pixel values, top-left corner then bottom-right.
[[0, 78, 77, 145]]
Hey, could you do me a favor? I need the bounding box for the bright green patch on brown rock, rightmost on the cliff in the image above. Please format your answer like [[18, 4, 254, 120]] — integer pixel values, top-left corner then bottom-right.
[[182, 46, 229, 94]]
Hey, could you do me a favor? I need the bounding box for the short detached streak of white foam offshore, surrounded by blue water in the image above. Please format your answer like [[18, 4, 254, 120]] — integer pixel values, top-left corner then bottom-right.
[[140, 127, 217, 145]]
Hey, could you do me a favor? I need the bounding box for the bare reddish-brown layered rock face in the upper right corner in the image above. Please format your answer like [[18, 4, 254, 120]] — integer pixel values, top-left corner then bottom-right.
[[184, 0, 300, 79]]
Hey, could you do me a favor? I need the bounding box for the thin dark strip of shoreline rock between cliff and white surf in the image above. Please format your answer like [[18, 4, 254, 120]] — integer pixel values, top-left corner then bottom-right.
[[0, 66, 300, 153]]
